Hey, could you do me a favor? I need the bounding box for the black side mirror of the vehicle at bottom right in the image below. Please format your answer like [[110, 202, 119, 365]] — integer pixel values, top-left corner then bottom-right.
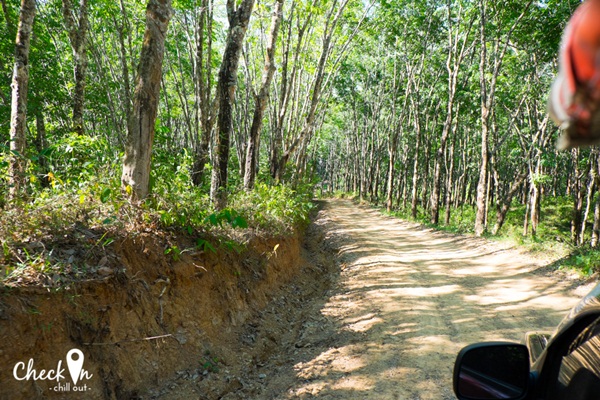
[[453, 342, 530, 400]]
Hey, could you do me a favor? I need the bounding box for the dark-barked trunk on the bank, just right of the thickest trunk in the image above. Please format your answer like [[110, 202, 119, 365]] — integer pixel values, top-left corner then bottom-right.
[[210, 0, 254, 210]]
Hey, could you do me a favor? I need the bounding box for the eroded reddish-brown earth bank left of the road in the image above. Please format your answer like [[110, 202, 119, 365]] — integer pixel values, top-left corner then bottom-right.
[[0, 223, 316, 400]]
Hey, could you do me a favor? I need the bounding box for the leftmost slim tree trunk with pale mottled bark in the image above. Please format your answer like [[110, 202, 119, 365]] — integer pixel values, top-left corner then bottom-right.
[[8, 0, 36, 200]]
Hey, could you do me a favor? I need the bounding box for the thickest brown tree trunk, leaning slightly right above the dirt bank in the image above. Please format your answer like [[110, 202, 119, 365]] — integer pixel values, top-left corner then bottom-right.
[[121, 0, 172, 200]]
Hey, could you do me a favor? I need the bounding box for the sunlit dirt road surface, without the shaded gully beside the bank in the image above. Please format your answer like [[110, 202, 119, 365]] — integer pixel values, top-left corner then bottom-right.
[[257, 200, 589, 400]]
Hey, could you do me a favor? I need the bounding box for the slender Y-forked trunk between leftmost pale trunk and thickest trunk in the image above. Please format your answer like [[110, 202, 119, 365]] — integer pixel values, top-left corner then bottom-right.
[[63, 0, 88, 135]]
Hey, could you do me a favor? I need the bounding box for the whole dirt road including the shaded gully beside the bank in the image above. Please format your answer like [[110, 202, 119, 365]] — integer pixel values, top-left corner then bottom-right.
[[153, 200, 592, 400]]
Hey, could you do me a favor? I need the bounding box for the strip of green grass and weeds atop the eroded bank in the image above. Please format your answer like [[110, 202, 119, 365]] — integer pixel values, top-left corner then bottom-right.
[[0, 157, 313, 287]]
